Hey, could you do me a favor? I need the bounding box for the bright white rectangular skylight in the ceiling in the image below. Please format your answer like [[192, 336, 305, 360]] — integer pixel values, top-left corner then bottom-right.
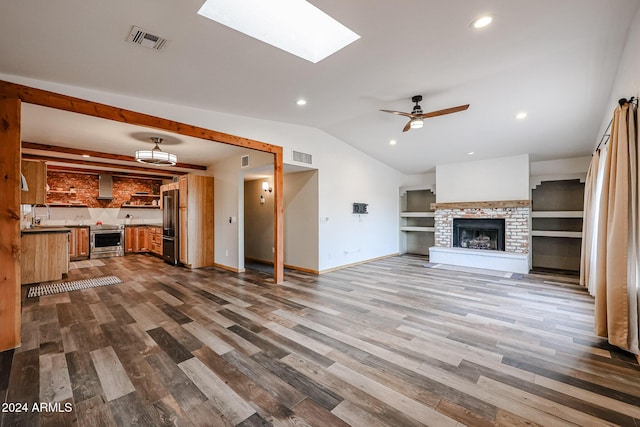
[[198, 0, 360, 64]]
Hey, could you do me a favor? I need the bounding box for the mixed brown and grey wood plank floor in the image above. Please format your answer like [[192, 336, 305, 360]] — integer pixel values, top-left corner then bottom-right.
[[0, 255, 640, 427]]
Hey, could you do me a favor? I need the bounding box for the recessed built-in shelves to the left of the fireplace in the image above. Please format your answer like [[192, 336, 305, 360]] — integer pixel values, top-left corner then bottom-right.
[[400, 188, 436, 255]]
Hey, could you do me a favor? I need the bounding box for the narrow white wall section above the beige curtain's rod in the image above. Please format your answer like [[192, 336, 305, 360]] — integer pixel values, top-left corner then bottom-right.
[[593, 5, 640, 149]]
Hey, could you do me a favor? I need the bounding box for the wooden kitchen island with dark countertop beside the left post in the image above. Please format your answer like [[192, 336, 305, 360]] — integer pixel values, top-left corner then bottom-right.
[[20, 227, 71, 285]]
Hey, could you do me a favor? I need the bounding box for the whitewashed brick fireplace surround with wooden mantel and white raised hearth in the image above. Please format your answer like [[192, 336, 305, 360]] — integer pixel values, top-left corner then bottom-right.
[[429, 200, 531, 274]]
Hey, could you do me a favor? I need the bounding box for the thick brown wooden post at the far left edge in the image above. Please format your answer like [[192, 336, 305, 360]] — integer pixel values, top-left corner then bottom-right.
[[0, 98, 20, 351]]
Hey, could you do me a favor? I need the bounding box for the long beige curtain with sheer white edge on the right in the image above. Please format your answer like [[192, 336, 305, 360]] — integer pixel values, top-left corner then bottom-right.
[[581, 103, 640, 354]]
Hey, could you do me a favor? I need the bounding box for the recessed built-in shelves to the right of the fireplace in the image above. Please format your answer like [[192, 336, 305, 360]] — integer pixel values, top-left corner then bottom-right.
[[531, 179, 584, 272]]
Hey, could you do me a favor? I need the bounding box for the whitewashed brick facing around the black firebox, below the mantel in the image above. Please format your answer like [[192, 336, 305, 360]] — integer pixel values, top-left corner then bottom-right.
[[435, 207, 531, 254]]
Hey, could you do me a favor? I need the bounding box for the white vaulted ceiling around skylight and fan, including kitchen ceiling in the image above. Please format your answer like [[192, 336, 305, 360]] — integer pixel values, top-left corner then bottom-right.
[[0, 0, 639, 174]]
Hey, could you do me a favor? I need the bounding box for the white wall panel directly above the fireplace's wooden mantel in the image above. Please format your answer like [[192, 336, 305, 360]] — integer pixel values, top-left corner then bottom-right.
[[436, 154, 530, 203]]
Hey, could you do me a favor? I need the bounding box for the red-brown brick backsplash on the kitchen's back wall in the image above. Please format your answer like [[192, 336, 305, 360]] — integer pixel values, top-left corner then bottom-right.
[[47, 170, 162, 208]]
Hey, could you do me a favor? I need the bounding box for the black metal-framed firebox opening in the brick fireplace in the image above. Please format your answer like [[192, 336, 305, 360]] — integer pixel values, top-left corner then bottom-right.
[[453, 218, 504, 251]]
